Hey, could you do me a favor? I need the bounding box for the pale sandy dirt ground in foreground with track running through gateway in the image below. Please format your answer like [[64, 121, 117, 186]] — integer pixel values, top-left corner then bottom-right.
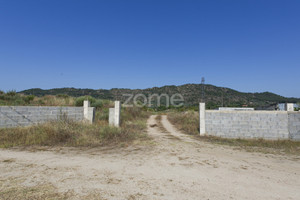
[[0, 116, 300, 200]]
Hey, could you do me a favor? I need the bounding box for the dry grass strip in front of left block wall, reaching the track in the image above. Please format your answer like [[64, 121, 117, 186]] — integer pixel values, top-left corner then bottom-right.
[[0, 109, 147, 148]]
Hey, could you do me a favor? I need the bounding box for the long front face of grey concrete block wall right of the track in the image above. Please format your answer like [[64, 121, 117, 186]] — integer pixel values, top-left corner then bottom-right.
[[205, 110, 290, 139]]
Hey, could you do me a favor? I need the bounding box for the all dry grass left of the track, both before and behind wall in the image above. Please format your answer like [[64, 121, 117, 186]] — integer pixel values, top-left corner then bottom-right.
[[0, 91, 149, 147]]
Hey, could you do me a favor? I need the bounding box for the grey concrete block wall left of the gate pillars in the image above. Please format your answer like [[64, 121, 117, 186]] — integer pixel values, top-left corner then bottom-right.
[[0, 106, 84, 128]]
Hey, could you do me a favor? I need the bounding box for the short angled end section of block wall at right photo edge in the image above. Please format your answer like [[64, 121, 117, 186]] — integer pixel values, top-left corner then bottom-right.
[[288, 112, 300, 140]]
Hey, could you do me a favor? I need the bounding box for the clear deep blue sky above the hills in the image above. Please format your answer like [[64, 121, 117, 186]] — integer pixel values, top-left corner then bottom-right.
[[0, 0, 300, 97]]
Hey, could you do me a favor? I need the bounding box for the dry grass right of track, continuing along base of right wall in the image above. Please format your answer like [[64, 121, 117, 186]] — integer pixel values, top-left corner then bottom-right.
[[167, 111, 300, 155]]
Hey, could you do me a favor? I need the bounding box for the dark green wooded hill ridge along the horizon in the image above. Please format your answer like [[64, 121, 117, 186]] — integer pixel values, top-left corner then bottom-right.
[[19, 84, 300, 108]]
